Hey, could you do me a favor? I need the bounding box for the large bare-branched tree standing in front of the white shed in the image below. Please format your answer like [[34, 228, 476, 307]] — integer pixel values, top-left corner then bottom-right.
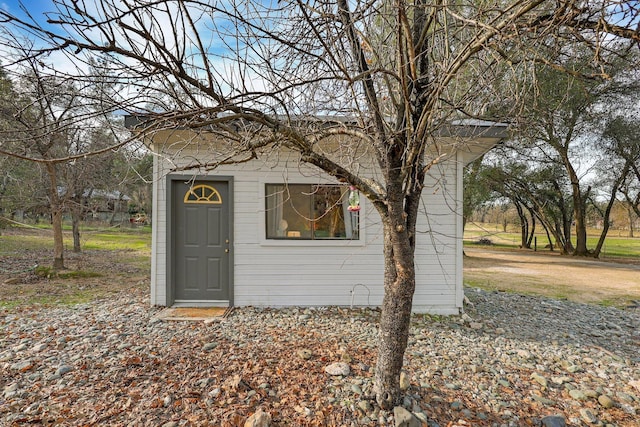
[[0, 0, 640, 408]]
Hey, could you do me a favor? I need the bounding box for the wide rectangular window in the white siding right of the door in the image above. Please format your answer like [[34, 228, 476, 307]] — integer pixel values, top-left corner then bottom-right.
[[265, 184, 360, 240]]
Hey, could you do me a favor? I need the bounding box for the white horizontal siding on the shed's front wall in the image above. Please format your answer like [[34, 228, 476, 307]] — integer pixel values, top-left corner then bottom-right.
[[151, 145, 462, 314]]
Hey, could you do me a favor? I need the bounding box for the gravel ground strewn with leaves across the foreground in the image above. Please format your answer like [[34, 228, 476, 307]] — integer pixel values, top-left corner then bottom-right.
[[0, 289, 640, 427]]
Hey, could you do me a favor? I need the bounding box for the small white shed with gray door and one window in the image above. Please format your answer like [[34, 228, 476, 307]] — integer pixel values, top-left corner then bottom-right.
[[132, 118, 506, 314]]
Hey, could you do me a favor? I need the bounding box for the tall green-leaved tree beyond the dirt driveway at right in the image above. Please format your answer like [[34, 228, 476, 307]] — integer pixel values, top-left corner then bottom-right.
[[500, 43, 640, 258]]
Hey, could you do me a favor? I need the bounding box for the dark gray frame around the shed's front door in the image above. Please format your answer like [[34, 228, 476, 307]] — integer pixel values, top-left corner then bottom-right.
[[166, 174, 235, 307]]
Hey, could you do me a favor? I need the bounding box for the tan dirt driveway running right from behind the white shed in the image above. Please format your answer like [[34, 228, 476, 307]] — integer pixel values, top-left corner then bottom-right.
[[464, 247, 640, 307]]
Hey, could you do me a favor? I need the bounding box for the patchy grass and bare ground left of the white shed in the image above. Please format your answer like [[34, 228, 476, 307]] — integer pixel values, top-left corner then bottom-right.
[[0, 227, 151, 309]]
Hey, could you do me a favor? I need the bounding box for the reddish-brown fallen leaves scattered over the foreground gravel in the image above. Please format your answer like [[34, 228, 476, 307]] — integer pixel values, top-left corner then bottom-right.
[[0, 286, 638, 427]]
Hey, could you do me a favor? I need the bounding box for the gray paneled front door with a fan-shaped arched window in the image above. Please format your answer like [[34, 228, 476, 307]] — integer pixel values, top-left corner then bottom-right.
[[171, 180, 232, 304]]
